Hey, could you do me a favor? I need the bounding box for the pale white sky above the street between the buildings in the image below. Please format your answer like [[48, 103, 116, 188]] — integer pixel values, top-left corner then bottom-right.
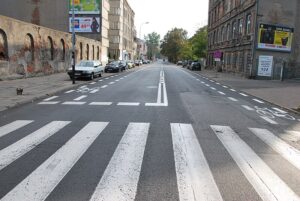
[[128, 0, 208, 39]]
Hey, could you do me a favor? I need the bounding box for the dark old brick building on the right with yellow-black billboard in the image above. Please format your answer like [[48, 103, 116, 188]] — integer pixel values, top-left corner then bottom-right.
[[207, 0, 300, 79]]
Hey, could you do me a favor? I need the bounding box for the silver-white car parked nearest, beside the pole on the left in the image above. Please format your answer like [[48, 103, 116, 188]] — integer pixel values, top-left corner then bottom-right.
[[67, 60, 104, 80]]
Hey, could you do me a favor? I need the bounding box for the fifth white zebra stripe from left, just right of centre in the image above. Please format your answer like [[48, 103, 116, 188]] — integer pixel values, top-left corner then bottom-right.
[[171, 124, 223, 201]]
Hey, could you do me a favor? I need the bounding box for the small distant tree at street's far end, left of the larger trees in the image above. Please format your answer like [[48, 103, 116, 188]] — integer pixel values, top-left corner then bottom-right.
[[145, 32, 160, 60]]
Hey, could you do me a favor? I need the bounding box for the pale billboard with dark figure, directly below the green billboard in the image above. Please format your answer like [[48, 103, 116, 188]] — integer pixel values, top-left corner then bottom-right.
[[69, 17, 101, 33]]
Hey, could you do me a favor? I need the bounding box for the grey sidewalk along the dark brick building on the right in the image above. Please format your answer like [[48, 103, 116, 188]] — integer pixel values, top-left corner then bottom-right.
[[198, 70, 300, 112]]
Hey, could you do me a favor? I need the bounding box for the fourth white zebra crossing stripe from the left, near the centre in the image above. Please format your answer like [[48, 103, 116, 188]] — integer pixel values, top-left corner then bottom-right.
[[90, 123, 150, 201]]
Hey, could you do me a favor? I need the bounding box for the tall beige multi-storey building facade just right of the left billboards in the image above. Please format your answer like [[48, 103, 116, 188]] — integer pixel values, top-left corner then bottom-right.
[[108, 0, 135, 60]]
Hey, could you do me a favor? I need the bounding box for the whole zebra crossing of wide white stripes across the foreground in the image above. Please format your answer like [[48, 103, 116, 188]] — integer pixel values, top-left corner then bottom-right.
[[0, 120, 300, 201]]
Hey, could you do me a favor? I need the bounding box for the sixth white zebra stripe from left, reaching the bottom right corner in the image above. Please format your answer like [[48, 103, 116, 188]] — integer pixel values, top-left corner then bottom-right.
[[211, 126, 300, 201]]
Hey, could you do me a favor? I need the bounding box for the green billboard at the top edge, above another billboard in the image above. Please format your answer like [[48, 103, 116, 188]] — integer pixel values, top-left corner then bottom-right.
[[69, 0, 102, 14]]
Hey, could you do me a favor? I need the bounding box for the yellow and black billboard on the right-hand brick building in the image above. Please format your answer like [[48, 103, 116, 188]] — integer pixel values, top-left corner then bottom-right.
[[257, 24, 294, 52]]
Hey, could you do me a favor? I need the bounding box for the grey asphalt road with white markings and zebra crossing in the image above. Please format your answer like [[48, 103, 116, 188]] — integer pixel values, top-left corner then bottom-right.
[[0, 62, 300, 201]]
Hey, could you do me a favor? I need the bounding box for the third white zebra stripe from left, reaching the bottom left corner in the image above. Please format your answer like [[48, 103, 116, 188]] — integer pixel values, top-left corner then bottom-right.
[[1, 122, 108, 201]]
